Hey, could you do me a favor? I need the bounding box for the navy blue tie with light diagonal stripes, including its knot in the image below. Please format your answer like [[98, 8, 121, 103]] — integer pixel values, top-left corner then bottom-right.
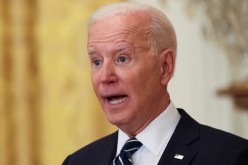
[[113, 138, 142, 165]]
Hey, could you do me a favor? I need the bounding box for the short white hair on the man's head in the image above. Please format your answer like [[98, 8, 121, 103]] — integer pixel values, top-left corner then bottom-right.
[[89, 2, 177, 54]]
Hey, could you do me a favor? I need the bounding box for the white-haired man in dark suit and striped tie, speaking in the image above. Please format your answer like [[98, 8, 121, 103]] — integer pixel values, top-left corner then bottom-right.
[[63, 3, 248, 165]]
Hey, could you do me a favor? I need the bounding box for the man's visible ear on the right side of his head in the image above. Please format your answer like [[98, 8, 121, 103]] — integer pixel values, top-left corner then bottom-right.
[[159, 49, 175, 85]]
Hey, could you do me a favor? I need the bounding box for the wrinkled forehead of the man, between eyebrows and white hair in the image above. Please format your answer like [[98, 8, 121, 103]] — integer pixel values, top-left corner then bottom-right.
[[88, 15, 149, 46]]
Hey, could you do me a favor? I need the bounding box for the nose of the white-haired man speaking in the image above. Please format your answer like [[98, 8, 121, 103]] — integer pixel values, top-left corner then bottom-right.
[[101, 62, 117, 84]]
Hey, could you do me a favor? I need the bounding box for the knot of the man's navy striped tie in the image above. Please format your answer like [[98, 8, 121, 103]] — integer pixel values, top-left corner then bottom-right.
[[121, 138, 142, 155]]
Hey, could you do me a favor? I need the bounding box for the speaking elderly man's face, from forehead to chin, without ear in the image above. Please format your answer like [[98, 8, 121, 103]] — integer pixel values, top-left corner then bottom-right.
[[88, 16, 169, 133]]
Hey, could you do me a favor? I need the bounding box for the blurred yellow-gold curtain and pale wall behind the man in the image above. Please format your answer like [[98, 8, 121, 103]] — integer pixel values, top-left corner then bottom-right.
[[0, 0, 248, 165]]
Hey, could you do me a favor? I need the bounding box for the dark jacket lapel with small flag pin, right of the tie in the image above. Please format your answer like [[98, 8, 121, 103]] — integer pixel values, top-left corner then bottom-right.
[[158, 109, 200, 165]]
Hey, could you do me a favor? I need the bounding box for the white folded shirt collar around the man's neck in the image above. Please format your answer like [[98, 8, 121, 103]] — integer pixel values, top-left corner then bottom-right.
[[116, 102, 180, 155]]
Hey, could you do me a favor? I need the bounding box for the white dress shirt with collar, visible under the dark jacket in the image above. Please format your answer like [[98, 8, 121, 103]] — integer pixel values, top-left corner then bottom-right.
[[116, 102, 180, 165]]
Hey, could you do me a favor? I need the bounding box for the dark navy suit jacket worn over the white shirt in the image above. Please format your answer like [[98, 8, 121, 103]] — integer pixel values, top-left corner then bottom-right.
[[63, 109, 248, 165]]
